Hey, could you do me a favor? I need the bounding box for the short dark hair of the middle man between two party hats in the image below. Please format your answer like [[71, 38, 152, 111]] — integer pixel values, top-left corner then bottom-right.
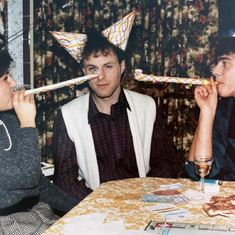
[[81, 31, 125, 63]]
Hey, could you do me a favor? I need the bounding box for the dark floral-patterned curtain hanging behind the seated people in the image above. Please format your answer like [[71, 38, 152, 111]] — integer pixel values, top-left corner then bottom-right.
[[34, 0, 218, 174]]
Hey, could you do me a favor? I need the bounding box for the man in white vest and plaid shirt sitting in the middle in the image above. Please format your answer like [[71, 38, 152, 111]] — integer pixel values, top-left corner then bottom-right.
[[51, 10, 177, 200]]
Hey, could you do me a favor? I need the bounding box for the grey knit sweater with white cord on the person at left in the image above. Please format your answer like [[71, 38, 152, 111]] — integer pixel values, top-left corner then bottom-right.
[[0, 115, 41, 189]]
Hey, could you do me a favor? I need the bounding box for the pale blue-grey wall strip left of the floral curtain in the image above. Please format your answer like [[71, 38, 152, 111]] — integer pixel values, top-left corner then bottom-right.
[[6, 0, 34, 88]]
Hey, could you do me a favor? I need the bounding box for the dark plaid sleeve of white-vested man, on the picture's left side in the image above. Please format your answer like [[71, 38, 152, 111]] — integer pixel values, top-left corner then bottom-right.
[[53, 111, 92, 201]]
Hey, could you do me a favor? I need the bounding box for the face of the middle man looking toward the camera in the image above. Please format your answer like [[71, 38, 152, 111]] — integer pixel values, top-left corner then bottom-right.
[[84, 52, 125, 101]]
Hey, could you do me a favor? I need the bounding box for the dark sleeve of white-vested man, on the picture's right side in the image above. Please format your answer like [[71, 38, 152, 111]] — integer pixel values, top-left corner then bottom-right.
[[147, 109, 178, 178]]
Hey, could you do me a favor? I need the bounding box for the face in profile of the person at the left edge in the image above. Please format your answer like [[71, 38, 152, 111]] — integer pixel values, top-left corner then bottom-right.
[[0, 73, 16, 111]]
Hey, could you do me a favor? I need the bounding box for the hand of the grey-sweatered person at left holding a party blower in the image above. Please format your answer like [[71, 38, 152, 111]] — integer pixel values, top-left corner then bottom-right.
[[13, 89, 36, 127]]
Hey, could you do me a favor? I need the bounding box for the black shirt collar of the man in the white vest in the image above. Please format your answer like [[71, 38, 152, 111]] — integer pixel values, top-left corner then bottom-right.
[[88, 88, 131, 123]]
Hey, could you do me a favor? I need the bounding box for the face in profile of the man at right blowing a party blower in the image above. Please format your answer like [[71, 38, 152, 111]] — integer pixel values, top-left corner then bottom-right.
[[213, 53, 235, 97]]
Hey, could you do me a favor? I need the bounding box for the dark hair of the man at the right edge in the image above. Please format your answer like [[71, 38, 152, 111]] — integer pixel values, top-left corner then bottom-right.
[[215, 37, 235, 59]]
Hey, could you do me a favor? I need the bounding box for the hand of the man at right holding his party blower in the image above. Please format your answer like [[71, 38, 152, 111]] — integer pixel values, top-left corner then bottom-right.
[[194, 78, 218, 114]]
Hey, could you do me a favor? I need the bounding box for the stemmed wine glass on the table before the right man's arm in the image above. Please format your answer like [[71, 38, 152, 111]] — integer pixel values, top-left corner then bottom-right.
[[194, 155, 214, 192]]
